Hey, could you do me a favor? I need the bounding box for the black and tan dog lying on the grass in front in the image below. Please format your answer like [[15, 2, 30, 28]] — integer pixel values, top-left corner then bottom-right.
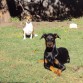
[[41, 33, 70, 75]]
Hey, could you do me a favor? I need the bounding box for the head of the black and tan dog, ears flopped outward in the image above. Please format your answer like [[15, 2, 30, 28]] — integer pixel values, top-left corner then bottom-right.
[[41, 33, 60, 48]]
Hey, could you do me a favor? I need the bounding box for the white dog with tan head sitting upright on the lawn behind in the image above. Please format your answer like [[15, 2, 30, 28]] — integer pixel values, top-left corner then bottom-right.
[[23, 16, 37, 39]]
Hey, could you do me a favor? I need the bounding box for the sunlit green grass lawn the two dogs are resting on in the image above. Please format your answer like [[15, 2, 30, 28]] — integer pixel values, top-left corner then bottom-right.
[[0, 17, 83, 83]]
